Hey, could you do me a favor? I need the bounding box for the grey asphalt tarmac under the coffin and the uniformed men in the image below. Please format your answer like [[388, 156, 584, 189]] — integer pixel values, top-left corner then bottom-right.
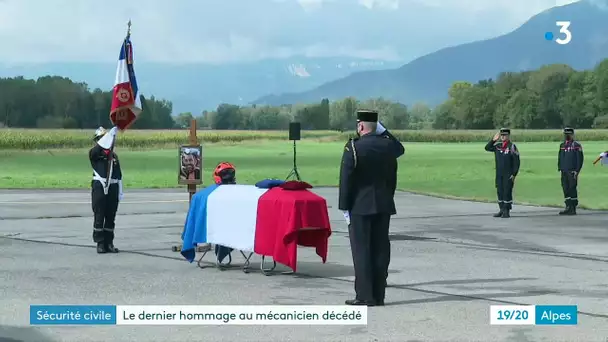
[[0, 188, 608, 342]]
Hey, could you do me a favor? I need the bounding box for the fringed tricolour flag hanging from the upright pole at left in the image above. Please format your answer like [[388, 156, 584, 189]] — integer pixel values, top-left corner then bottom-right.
[[110, 26, 142, 131]]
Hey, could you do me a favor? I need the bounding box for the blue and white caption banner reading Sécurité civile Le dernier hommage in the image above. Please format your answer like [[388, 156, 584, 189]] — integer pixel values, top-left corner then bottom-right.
[[30, 305, 367, 325]]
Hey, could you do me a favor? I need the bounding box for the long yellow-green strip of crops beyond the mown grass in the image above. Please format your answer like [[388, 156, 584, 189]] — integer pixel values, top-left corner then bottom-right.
[[0, 129, 608, 150]]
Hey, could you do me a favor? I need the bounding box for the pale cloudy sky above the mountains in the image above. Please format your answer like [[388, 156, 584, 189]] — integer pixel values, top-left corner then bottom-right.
[[0, 0, 580, 64]]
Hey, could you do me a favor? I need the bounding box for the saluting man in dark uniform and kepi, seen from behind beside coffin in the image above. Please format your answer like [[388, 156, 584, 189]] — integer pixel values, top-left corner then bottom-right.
[[338, 111, 405, 306]]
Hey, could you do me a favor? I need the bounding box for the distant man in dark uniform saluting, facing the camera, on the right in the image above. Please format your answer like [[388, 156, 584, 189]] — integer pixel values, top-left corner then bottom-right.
[[486, 128, 520, 218]]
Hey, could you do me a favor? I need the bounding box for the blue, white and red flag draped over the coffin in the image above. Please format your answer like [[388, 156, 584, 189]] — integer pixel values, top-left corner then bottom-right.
[[182, 184, 331, 271]]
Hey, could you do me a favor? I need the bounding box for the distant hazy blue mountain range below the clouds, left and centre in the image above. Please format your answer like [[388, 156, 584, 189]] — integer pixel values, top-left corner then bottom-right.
[[0, 57, 399, 115]]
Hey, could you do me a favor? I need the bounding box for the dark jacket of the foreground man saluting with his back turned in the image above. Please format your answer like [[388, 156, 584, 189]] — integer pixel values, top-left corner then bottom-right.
[[338, 131, 405, 215]]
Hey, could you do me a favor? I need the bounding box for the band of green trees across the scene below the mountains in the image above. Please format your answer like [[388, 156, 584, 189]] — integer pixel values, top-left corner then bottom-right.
[[0, 59, 608, 131]]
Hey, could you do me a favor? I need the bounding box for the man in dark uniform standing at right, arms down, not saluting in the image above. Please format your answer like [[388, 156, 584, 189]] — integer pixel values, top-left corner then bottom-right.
[[557, 127, 584, 215]]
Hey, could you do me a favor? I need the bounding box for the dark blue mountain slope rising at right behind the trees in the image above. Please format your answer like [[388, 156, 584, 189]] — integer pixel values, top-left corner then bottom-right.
[[252, 1, 608, 105]]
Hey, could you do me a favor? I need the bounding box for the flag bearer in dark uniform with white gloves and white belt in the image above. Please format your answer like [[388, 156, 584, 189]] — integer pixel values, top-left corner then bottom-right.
[[89, 127, 122, 253]]
